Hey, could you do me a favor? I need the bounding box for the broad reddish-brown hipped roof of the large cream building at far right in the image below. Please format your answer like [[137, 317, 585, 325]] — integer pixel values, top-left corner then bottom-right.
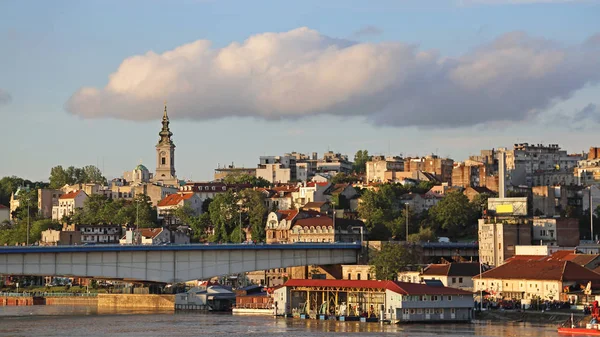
[[473, 260, 600, 282]]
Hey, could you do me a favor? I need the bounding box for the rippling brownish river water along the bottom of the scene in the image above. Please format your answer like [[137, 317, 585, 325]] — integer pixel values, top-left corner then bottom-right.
[[0, 306, 557, 337]]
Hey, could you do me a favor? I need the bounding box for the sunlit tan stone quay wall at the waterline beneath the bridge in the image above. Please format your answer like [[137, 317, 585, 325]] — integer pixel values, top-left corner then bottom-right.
[[98, 294, 175, 310]]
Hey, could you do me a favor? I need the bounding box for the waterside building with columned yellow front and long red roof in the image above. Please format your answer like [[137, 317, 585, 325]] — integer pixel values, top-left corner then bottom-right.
[[273, 279, 474, 323]]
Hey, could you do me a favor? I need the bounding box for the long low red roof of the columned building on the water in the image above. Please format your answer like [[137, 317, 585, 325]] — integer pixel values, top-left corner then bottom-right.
[[283, 279, 472, 295]]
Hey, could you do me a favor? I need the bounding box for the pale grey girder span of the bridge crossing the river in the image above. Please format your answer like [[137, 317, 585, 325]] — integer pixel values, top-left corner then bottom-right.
[[0, 243, 361, 283]]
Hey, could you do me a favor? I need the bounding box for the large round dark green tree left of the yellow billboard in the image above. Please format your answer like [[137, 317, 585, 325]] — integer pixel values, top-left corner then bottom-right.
[[429, 191, 477, 237]]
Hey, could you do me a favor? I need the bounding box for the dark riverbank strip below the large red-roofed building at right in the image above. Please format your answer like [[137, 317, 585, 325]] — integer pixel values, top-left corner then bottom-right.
[[473, 310, 584, 324]]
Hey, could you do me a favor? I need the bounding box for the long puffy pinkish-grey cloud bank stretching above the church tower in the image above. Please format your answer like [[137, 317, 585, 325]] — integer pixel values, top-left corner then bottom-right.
[[66, 28, 600, 127]]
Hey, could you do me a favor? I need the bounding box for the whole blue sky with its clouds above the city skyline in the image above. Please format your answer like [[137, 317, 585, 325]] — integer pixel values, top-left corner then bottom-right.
[[0, 0, 600, 181]]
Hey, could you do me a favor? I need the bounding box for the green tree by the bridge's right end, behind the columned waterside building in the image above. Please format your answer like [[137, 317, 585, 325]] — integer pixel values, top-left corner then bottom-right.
[[371, 243, 415, 280]]
